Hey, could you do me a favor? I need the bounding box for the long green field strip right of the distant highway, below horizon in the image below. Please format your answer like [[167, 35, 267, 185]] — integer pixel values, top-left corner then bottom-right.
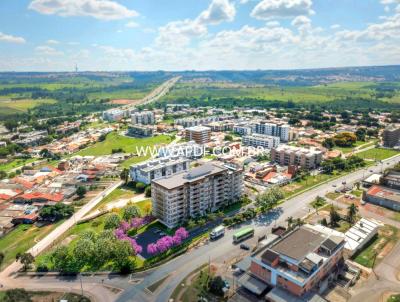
[[164, 82, 400, 102]]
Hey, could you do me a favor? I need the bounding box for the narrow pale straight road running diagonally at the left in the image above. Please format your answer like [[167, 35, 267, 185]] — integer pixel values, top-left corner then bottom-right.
[[0, 181, 123, 285]]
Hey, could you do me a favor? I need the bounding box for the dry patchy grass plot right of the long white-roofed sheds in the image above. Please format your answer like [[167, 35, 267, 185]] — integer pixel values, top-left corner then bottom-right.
[[353, 225, 399, 268]]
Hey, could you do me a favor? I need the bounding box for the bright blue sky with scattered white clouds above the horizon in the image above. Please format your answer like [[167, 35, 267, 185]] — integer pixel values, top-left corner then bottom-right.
[[0, 0, 400, 71]]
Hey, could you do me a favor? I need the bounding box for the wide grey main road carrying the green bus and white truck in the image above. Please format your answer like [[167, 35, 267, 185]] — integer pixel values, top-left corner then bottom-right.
[[3, 155, 400, 302]]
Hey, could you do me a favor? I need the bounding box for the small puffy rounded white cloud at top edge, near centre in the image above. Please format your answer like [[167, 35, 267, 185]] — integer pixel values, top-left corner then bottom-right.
[[198, 0, 236, 24]]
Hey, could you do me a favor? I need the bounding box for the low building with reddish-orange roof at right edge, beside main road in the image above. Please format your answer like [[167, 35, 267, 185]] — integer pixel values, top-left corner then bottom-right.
[[363, 185, 400, 211]]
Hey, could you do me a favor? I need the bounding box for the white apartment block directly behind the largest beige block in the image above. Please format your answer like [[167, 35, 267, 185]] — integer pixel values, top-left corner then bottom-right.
[[129, 156, 190, 184]]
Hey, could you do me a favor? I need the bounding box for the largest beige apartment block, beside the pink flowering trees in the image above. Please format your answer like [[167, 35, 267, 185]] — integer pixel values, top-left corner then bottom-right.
[[151, 163, 243, 228]]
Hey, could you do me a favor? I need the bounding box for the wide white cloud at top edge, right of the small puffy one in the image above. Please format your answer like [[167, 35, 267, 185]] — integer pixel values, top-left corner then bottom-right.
[[251, 0, 314, 20]]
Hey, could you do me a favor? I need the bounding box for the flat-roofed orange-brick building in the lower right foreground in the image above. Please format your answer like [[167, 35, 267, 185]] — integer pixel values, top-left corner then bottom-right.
[[245, 225, 345, 301]]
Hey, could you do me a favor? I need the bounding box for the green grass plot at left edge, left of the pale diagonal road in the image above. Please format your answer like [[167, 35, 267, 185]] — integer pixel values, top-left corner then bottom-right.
[[0, 220, 63, 268]]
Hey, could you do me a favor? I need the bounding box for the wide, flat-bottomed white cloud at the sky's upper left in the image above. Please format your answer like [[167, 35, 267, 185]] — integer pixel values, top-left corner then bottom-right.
[[29, 0, 138, 20]]
